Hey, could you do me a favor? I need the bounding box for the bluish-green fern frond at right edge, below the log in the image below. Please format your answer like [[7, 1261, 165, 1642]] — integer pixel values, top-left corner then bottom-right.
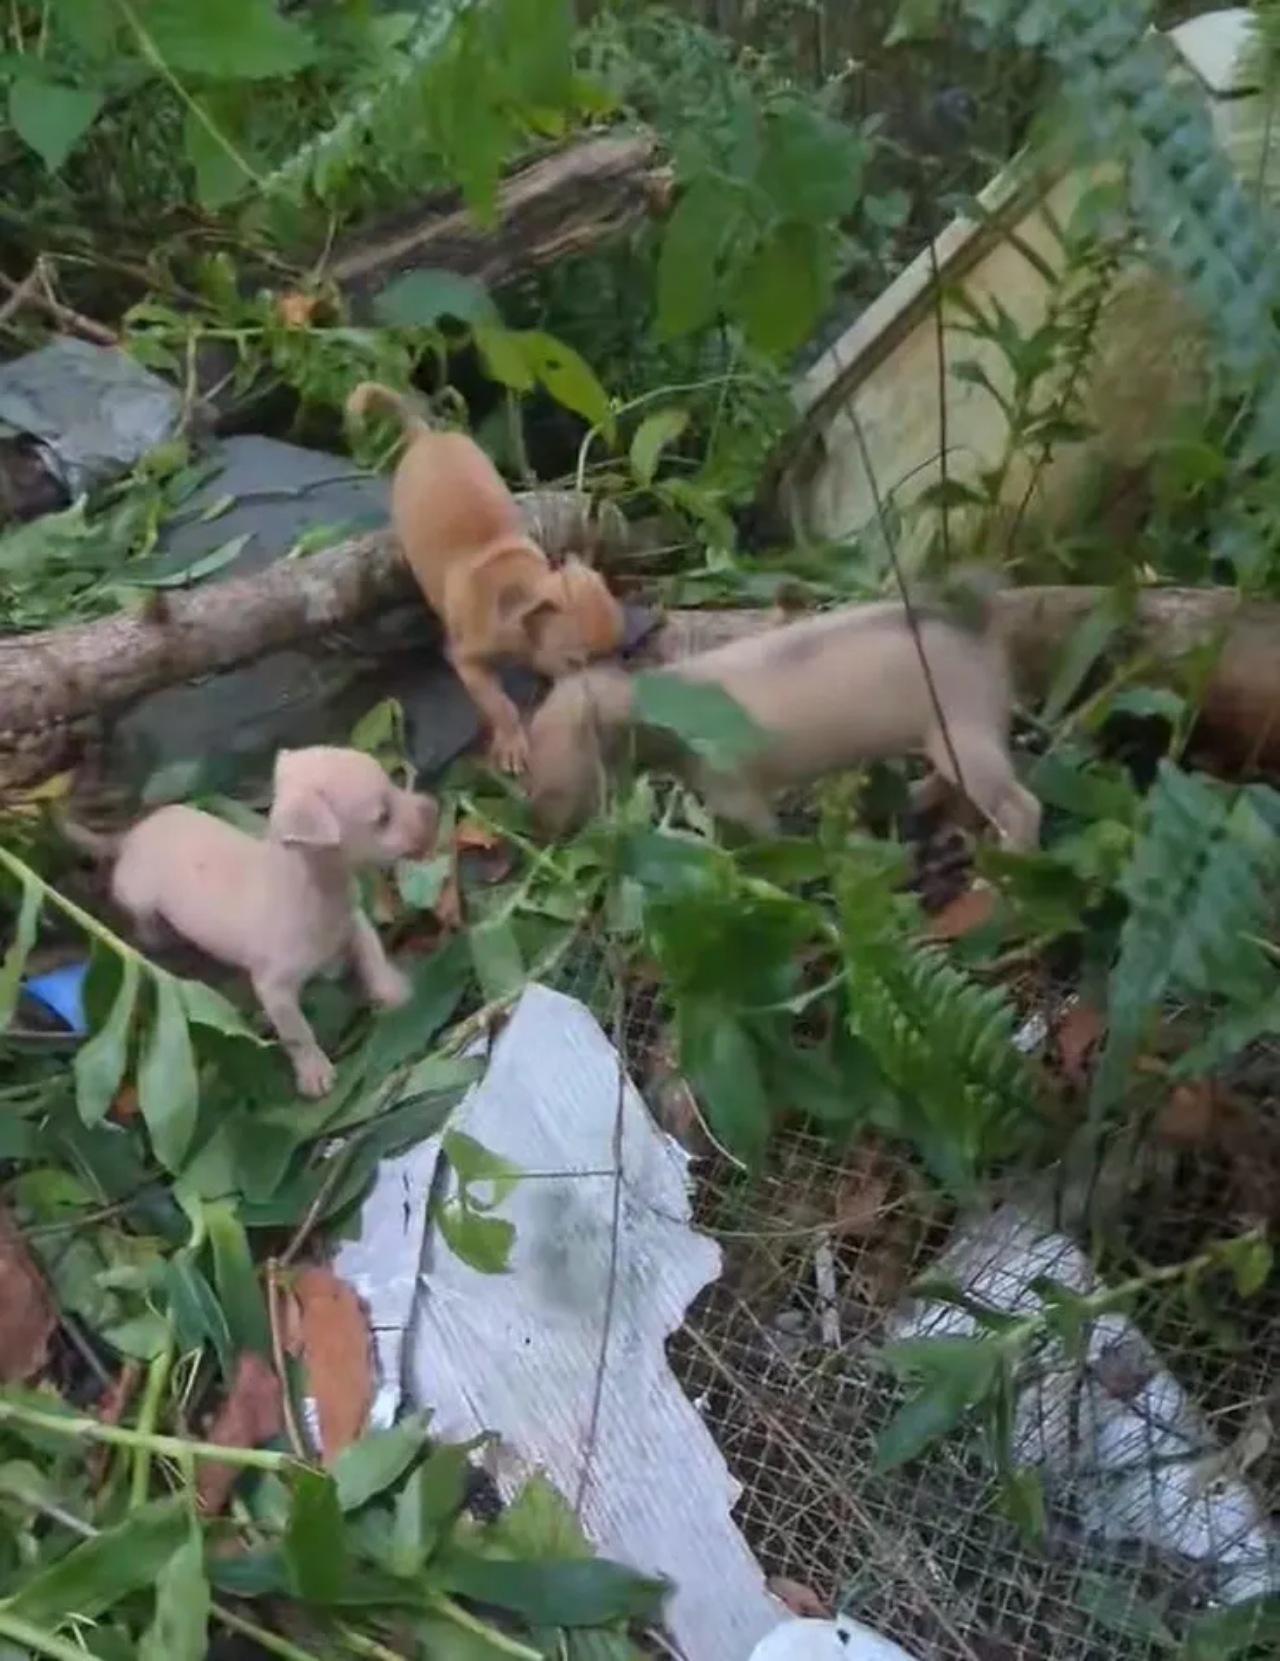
[[1092, 761, 1280, 1113]]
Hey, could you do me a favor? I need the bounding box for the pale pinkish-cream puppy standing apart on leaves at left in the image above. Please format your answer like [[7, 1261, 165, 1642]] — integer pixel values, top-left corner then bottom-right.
[[61, 746, 440, 1096]]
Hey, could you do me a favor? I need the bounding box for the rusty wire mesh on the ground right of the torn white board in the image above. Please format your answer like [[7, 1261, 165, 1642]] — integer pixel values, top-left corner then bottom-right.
[[544, 948, 1280, 1661]]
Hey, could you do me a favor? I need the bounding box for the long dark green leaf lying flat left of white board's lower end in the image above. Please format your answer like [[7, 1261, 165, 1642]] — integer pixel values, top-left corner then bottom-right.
[[440, 1551, 667, 1626]]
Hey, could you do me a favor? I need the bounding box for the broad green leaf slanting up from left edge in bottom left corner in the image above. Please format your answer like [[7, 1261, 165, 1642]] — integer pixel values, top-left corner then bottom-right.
[[5, 1497, 191, 1623]]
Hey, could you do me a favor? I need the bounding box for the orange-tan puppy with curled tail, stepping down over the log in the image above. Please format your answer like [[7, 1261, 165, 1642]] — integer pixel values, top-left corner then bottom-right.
[[347, 380, 623, 772]]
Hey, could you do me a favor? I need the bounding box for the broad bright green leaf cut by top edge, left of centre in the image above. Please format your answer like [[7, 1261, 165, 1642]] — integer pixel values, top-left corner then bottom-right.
[[138, 0, 315, 81]]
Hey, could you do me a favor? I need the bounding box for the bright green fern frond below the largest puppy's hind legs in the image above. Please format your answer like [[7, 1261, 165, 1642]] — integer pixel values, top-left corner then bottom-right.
[[838, 872, 1036, 1189]]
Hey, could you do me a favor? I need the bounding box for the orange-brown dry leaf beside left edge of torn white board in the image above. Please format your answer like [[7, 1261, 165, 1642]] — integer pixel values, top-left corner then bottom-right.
[[294, 1266, 374, 1463]]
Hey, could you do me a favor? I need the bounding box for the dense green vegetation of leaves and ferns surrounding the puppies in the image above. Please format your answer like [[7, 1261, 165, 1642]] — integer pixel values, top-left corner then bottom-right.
[[0, 0, 1280, 1661]]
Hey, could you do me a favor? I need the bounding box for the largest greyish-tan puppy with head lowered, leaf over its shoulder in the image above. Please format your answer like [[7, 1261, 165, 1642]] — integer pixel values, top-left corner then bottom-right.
[[530, 593, 1041, 847]]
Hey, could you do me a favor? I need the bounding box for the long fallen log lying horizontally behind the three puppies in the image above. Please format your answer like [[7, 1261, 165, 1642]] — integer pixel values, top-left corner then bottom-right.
[[0, 561, 1280, 784]]
